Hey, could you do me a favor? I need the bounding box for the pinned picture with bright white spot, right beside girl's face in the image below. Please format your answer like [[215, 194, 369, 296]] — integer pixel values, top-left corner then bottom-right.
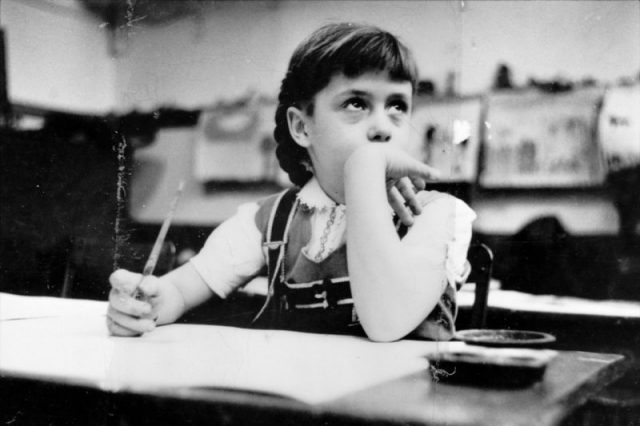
[[407, 97, 482, 182]]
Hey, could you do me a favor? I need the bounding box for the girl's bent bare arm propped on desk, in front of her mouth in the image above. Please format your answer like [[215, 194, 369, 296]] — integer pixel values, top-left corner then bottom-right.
[[345, 144, 455, 341]]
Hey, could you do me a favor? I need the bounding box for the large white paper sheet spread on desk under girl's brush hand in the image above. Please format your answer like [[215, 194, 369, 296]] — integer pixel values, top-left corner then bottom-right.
[[0, 295, 444, 404]]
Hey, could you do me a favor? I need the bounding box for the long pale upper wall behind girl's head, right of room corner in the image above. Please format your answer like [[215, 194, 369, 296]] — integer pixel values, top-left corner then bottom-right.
[[112, 1, 640, 110]]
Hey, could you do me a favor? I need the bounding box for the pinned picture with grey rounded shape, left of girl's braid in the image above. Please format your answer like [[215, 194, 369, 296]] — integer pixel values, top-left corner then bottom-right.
[[193, 95, 288, 186]]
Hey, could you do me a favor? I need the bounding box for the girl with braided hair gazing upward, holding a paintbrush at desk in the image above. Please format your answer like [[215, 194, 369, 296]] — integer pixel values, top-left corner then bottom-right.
[[107, 23, 475, 341]]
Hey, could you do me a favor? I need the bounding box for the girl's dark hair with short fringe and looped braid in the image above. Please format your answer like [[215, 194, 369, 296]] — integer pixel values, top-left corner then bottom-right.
[[273, 23, 418, 186]]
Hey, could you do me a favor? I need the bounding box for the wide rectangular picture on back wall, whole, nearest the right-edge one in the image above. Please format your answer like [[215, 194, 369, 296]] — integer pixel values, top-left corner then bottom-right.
[[479, 88, 605, 188]]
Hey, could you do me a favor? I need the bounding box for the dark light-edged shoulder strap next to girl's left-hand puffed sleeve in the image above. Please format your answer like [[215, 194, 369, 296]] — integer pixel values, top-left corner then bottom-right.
[[252, 188, 298, 322]]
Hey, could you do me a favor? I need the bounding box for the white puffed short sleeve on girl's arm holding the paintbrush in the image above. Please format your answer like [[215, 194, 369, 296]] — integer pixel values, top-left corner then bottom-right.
[[190, 203, 265, 298]]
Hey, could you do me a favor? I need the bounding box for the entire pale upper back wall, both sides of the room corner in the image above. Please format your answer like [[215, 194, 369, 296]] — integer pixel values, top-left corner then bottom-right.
[[0, 0, 640, 113]]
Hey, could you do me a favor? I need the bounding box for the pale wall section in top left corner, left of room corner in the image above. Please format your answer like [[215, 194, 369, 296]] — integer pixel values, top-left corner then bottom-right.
[[0, 0, 116, 114]]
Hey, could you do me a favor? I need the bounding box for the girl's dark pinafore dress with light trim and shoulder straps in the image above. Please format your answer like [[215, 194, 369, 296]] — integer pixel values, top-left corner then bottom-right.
[[254, 189, 457, 340]]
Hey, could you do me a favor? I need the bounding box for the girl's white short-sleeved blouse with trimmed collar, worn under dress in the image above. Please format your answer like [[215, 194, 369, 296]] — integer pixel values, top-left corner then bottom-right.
[[190, 178, 476, 298]]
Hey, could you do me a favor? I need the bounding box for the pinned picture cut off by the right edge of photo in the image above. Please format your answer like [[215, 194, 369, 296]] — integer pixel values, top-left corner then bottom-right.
[[598, 85, 640, 171]]
